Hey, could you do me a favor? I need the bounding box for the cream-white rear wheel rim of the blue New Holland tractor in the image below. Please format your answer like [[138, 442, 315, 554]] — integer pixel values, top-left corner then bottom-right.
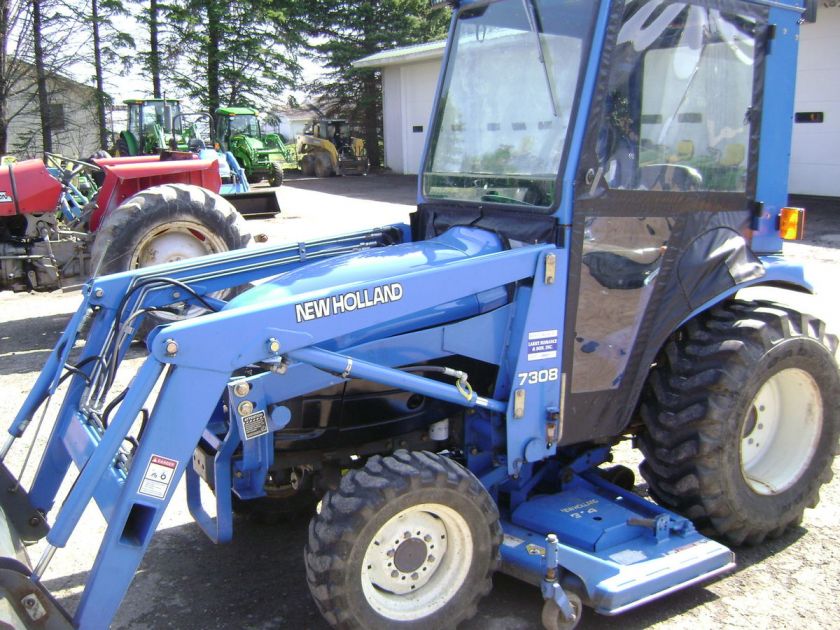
[[741, 368, 823, 496]]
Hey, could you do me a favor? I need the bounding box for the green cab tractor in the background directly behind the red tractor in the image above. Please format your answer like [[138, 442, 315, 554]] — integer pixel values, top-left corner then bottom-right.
[[116, 98, 196, 156]]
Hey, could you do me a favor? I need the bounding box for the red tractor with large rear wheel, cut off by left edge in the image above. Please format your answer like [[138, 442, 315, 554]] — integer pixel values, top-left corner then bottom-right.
[[0, 152, 258, 291]]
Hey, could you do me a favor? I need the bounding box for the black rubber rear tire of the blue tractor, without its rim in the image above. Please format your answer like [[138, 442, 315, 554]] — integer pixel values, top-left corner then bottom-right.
[[639, 301, 840, 545]]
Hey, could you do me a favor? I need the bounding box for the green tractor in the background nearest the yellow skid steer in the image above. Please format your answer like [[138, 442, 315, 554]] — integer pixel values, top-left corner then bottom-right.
[[216, 107, 297, 186]]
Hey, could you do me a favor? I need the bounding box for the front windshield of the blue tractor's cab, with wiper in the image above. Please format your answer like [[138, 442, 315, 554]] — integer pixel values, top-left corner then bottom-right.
[[423, 0, 597, 208]]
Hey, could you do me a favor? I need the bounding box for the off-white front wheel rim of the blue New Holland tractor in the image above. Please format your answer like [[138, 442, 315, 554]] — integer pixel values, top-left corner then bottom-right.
[[361, 503, 473, 621]]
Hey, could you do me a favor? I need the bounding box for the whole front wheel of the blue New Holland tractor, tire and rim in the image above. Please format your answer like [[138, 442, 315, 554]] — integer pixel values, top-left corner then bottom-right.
[[304, 450, 502, 630]]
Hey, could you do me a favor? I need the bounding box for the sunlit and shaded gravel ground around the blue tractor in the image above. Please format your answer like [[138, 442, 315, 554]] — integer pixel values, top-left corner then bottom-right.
[[0, 177, 840, 630]]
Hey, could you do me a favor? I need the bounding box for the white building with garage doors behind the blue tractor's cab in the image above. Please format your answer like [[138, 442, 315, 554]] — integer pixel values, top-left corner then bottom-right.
[[353, 12, 840, 197]]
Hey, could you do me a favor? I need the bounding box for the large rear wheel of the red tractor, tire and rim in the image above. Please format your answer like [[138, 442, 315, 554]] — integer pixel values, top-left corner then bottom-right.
[[91, 184, 251, 338]]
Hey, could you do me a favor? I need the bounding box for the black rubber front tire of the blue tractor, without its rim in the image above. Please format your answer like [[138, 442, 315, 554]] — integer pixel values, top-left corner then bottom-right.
[[304, 450, 502, 629]]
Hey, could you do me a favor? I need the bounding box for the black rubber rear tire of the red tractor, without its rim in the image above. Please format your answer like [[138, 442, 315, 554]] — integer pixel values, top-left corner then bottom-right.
[[90, 184, 251, 337]]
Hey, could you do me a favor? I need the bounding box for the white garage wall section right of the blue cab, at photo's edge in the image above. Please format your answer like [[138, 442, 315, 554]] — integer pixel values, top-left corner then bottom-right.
[[788, 8, 840, 197]]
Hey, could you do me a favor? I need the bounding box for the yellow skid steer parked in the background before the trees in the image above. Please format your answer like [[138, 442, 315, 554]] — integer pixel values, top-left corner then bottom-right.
[[295, 117, 370, 177]]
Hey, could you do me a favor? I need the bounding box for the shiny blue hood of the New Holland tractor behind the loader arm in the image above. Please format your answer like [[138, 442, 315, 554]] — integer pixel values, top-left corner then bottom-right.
[[226, 227, 508, 350]]
